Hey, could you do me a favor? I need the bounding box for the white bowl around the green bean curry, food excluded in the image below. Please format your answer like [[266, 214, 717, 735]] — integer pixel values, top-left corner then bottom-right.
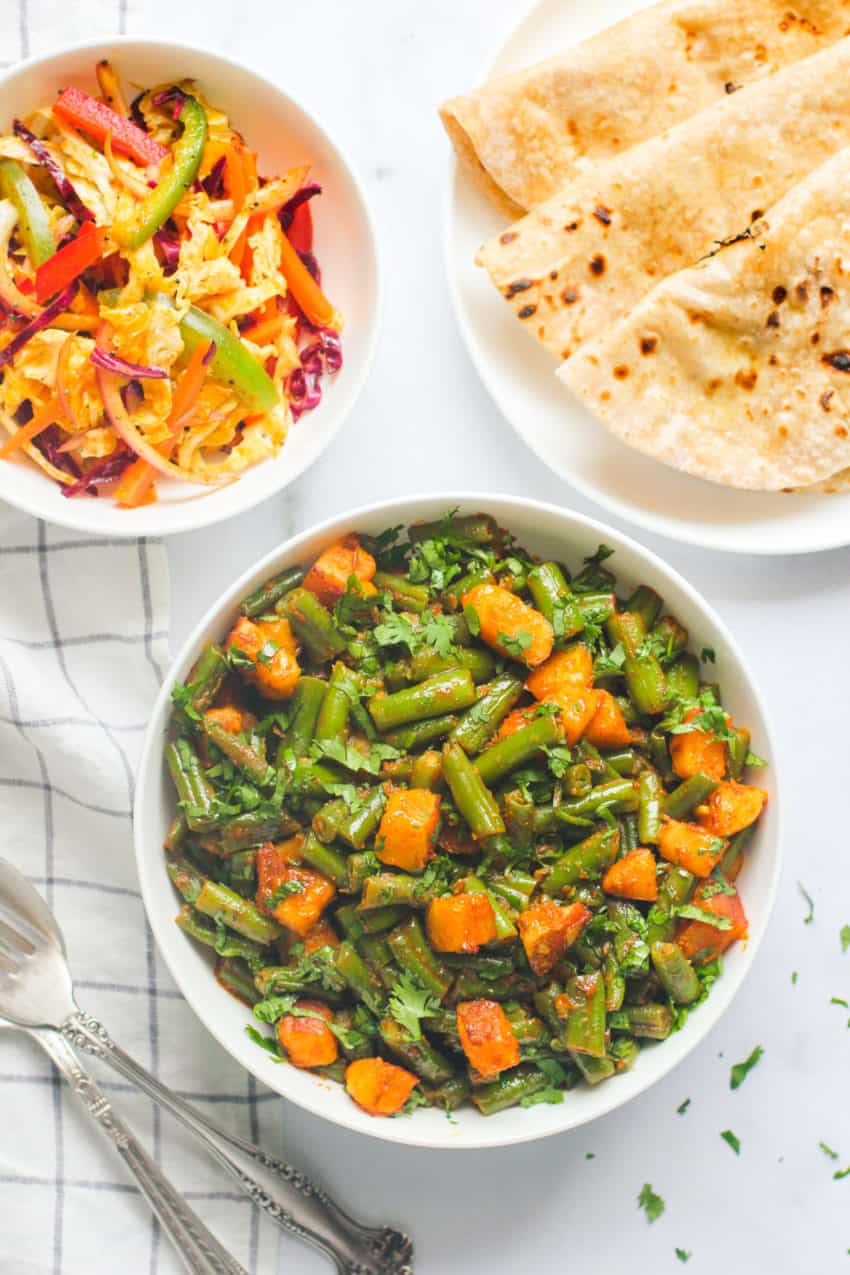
[[134, 492, 780, 1148]]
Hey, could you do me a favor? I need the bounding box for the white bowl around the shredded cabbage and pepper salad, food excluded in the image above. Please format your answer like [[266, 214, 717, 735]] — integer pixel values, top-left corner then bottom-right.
[[0, 37, 381, 537]]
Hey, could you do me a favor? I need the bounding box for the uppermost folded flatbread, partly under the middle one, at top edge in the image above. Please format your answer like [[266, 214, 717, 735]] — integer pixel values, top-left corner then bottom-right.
[[440, 0, 850, 209]]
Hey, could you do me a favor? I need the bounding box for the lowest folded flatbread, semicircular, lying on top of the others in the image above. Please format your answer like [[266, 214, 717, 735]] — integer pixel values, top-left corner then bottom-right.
[[558, 148, 850, 491]]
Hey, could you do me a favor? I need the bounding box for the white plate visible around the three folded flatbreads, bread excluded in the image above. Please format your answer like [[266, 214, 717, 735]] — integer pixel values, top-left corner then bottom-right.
[[446, 0, 850, 553]]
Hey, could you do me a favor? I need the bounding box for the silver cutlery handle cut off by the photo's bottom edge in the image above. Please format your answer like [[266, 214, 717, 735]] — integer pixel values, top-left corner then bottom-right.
[[27, 1029, 247, 1275]]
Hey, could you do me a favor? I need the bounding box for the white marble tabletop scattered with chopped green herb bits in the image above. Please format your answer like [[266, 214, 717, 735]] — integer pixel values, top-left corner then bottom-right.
[[9, 0, 850, 1275]]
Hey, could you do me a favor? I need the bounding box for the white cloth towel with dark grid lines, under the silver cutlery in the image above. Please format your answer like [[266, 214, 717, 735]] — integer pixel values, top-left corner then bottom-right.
[[0, 506, 280, 1275]]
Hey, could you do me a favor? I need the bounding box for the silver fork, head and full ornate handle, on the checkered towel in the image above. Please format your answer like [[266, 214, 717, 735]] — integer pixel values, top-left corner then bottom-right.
[[0, 859, 413, 1275]]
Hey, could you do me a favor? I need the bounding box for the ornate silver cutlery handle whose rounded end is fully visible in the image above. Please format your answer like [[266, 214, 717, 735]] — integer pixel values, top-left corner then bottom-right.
[[62, 1011, 413, 1275]]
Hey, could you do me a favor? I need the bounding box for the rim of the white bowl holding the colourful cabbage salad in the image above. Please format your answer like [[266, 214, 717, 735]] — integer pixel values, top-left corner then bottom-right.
[[0, 32, 386, 539]]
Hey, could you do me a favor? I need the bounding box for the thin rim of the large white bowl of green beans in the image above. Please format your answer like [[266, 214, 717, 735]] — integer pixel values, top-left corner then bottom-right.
[[133, 490, 784, 1150]]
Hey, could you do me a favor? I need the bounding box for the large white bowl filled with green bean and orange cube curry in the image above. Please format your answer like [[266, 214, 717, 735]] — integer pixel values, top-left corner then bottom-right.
[[135, 493, 780, 1148]]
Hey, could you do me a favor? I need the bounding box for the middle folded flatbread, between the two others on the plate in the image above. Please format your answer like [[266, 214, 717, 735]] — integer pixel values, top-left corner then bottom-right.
[[478, 36, 850, 362]]
